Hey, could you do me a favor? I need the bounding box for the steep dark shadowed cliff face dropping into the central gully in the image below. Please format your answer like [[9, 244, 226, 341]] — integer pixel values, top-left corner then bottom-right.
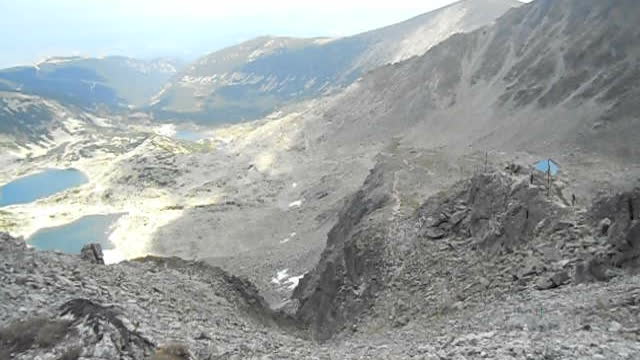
[[293, 163, 390, 340]]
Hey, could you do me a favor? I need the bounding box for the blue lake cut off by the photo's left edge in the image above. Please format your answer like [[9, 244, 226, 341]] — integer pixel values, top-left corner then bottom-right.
[[0, 169, 89, 206]]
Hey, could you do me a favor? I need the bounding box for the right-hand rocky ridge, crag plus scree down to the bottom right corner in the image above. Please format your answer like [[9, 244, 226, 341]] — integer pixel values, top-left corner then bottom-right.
[[294, 166, 640, 358]]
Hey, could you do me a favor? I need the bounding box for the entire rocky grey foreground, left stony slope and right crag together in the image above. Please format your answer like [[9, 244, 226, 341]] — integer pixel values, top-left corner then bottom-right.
[[5, 162, 640, 359]]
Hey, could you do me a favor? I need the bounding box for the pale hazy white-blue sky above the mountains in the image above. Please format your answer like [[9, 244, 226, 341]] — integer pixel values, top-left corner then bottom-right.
[[0, 0, 524, 67]]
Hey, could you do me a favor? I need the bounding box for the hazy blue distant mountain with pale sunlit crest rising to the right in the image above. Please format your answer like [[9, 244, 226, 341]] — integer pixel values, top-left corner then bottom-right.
[[152, 0, 520, 123]]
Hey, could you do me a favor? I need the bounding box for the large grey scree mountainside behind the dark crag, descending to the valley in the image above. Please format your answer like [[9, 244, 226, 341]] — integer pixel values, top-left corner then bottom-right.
[[142, 0, 640, 302]]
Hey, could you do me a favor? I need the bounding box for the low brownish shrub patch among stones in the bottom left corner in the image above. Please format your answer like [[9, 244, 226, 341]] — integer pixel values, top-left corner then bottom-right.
[[0, 317, 71, 352]]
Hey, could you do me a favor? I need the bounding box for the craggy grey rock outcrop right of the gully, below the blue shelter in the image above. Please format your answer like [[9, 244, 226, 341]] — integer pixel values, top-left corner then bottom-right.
[[293, 162, 631, 350]]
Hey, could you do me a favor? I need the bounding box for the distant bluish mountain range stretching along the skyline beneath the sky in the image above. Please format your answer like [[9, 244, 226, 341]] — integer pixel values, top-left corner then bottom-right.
[[0, 0, 521, 125]]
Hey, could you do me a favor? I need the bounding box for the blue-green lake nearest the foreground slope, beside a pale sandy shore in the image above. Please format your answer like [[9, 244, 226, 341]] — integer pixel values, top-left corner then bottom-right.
[[27, 214, 122, 254]]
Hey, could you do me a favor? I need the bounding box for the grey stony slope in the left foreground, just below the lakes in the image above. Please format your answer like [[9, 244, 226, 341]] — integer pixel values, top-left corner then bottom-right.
[[0, 234, 308, 360]]
